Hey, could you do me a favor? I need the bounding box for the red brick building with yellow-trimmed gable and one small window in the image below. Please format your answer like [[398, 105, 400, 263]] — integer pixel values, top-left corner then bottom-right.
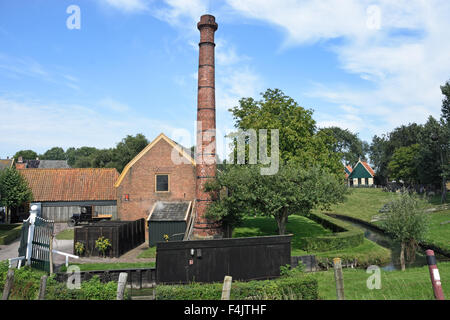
[[115, 133, 196, 232]]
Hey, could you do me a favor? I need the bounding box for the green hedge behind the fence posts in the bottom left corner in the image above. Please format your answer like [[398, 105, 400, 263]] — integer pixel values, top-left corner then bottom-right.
[[0, 261, 120, 300]]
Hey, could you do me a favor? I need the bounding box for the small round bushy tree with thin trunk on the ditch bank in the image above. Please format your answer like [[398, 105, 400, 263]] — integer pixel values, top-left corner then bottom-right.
[[381, 193, 429, 271]]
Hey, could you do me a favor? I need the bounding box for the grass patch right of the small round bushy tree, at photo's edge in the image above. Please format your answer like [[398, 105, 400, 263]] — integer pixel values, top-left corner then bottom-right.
[[427, 210, 450, 251]]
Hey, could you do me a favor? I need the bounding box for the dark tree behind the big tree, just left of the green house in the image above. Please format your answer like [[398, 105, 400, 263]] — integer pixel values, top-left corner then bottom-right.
[[320, 127, 369, 167]]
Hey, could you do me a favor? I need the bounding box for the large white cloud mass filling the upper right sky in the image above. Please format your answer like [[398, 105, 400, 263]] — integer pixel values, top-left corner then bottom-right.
[[227, 0, 450, 138]]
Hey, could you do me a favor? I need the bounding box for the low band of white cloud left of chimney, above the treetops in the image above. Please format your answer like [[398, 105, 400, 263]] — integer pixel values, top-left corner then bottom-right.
[[0, 96, 179, 156]]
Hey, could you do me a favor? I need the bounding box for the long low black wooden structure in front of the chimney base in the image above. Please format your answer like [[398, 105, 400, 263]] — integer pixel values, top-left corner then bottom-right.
[[156, 235, 292, 283]]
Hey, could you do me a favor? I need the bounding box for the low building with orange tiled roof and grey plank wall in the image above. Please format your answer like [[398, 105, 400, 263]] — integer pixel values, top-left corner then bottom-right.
[[17, 168, 119, 222]]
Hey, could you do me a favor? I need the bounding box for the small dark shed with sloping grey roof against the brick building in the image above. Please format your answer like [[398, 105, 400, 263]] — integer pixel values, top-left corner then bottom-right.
[[147, 201, 192, 247]]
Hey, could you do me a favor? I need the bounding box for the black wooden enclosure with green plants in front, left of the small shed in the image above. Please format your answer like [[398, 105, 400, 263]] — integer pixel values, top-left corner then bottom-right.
[[74, 219, 145, 258]]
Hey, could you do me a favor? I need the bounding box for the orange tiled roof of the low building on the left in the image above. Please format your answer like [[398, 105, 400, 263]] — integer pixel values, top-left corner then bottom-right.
[[19, 168, 119, 202]]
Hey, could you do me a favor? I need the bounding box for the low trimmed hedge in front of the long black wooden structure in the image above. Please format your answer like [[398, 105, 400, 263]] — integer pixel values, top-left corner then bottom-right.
[[156, 275, 319, 300]]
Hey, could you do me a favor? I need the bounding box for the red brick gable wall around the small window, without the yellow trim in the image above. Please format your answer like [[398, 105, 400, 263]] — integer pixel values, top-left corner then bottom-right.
[[117, 139, 196, 238]]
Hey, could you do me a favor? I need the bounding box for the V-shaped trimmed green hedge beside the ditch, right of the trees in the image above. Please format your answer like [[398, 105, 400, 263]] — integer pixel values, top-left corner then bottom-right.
[[301, 213, 364, 252]]
